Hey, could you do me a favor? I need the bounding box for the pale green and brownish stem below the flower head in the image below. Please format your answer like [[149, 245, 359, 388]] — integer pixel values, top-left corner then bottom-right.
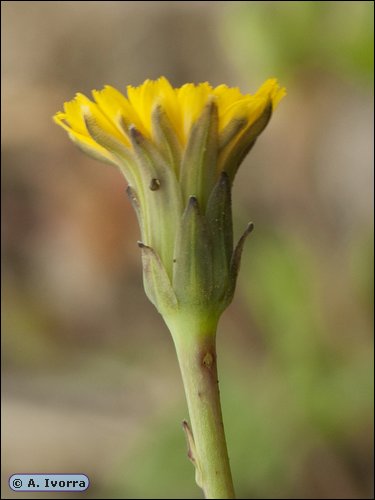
[[172, 318, 235, 499]]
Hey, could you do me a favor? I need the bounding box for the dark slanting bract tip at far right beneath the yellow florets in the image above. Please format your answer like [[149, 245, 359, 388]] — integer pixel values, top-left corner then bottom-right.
[[218, 103, 272, 181]]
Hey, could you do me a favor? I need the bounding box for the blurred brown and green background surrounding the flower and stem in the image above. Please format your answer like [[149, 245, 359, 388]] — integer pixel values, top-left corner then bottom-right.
[[1, 1, 374, 499]]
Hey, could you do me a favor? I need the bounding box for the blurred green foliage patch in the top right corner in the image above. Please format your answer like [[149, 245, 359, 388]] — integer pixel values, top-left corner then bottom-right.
[[223, 1, 374, 81]]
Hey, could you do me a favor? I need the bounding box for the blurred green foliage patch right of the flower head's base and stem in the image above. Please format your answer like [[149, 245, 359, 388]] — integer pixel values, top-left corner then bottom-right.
[[242, 227, 373, 439]]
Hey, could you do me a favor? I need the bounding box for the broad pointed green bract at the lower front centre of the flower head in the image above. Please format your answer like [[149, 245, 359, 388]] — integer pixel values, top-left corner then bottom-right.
[[173, 196, 213, 307]]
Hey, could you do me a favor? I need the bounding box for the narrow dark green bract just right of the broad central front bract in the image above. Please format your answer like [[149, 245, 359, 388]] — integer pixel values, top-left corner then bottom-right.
[[206, 172, 233, 300]]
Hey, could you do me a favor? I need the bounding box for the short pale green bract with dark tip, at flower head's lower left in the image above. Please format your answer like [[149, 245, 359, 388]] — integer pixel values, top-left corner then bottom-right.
[[138, 241, 178, 314]]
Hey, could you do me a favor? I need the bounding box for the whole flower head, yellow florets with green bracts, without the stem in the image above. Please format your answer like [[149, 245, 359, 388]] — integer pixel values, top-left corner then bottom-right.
[[54, 77, 285, 322]]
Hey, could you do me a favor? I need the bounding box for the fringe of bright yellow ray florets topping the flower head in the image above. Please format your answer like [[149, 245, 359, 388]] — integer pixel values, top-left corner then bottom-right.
[[54, 77, 286, 154]]
